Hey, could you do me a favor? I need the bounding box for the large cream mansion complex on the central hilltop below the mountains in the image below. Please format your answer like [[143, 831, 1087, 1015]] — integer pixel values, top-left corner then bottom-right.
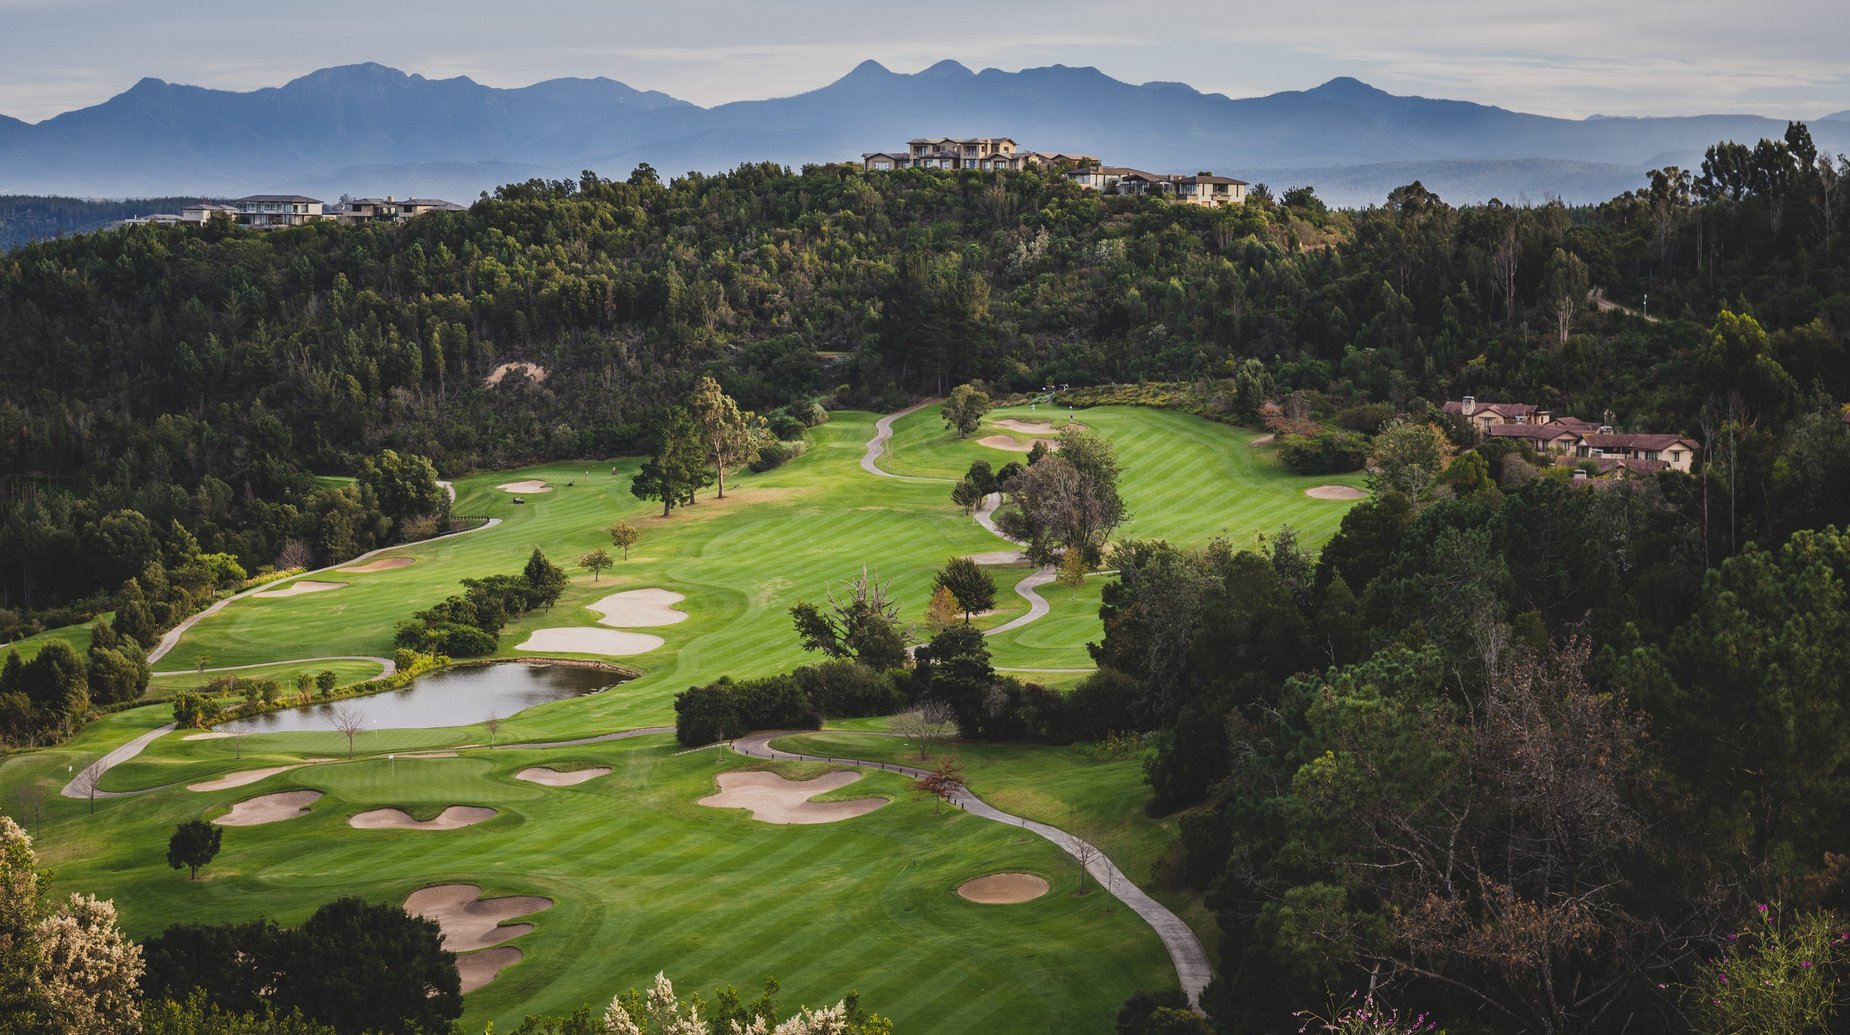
[[860, 137, 1247, 207]]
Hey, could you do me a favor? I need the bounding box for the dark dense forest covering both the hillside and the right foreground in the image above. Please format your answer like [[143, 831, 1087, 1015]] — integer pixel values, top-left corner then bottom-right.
[[0, 124, 1850, 1033]]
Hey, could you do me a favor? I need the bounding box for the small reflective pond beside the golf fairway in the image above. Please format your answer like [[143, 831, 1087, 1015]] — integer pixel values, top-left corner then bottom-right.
[[216, 663, 622, 733]]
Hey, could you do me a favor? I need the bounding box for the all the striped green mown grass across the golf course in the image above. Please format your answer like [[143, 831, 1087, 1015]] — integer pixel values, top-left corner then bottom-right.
[[0, 407, 1347, 1033]]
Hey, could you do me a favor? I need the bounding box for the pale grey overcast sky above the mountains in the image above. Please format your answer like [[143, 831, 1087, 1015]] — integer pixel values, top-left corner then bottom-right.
[[0, 0, 1850, 122]]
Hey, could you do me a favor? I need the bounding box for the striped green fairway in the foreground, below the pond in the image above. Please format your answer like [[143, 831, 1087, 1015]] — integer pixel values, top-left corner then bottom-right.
[[10, 737, 1175, 1035]]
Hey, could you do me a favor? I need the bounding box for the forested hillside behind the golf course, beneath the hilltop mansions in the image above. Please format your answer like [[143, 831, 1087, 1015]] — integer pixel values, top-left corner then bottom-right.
[[0, 126, 1850, 611]]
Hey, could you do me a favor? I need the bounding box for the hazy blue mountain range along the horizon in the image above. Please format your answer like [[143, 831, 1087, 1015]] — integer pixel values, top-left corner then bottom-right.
[[0, 61, 1850, 204]]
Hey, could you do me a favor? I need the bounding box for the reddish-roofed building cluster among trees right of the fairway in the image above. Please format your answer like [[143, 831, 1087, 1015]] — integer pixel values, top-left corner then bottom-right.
[[1445, 396, 1696, 478]]
